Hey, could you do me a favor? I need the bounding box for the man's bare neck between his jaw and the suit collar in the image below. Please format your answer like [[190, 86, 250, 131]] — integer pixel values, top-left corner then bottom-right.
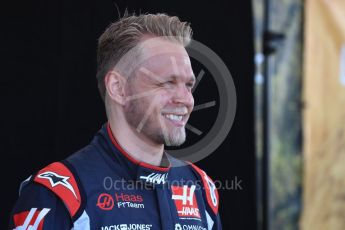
[[108, 119, 164, 166]]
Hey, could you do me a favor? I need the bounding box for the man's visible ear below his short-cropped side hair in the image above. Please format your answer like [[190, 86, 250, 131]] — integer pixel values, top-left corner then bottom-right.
[[104, 71, 126, 105]]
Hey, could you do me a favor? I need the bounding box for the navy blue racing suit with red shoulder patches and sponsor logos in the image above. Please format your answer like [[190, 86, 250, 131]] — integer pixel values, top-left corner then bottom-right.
[[9, 124, 222, 230]]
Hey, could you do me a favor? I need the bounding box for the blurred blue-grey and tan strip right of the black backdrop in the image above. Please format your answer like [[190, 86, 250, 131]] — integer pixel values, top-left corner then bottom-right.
[[253, 0, 345, 230]]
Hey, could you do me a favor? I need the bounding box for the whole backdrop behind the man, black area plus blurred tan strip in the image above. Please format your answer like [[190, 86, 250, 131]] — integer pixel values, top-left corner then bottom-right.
[[0, 0, 345, 230]]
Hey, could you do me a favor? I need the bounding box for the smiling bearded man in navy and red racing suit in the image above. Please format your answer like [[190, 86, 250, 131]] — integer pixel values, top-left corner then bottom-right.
[[10, 14, 221, 230]]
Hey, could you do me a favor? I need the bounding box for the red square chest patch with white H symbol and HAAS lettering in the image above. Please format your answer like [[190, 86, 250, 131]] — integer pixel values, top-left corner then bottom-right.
[[171, 185, 200, 219]]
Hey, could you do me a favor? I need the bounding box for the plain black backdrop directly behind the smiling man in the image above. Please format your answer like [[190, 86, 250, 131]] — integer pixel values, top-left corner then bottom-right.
[[0, 0, 256, 230]]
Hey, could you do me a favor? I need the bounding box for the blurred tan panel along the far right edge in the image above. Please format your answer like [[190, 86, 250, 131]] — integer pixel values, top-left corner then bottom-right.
[[301, 0, 345, 230]]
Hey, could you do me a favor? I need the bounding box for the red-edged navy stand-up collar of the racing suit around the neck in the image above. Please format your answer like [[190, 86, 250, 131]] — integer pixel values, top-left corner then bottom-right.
[[106, 123, 171, 185]]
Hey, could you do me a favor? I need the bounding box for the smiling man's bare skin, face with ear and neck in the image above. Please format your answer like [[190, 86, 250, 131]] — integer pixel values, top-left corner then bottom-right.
[[106, 35, 195, 165]]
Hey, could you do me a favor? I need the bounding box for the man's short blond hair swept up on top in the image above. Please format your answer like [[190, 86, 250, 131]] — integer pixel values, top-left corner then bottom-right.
[[97, 12, 192, 101]]
